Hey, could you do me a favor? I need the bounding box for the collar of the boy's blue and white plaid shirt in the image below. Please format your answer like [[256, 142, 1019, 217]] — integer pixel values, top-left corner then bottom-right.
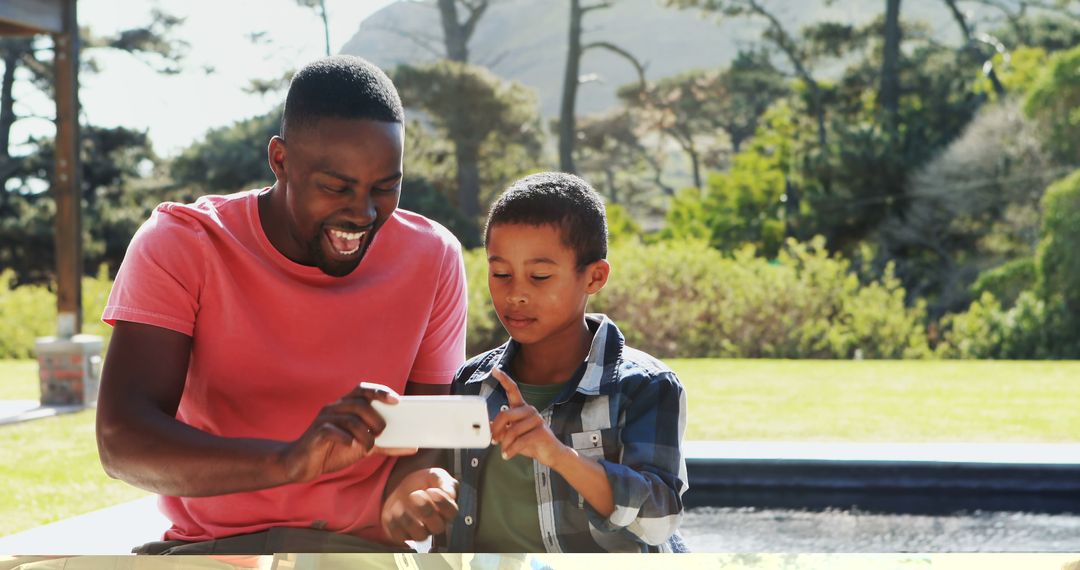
[[465, 313, 625, 404]]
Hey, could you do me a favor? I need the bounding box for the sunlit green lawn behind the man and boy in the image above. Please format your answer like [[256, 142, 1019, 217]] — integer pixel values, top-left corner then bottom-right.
[[0, 359, 1080, 535]]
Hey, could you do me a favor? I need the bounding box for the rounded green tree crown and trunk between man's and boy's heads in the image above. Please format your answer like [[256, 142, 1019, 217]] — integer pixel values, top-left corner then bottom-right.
[[393, 60, 540, 220]]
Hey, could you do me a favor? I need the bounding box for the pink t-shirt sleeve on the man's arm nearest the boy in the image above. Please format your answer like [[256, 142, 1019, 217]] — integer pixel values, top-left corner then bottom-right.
[[409, 241, 469, 384]]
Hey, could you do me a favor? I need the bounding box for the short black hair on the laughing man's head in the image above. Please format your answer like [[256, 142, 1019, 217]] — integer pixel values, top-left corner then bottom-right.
[[281, 55, 405, 136]]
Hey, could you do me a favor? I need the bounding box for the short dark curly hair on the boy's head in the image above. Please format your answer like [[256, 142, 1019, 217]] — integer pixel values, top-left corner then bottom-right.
[[484, 172, 607, 271]]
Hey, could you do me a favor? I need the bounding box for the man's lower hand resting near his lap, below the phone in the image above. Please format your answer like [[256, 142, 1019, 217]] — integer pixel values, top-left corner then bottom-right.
[[382, 467, 458, 542]]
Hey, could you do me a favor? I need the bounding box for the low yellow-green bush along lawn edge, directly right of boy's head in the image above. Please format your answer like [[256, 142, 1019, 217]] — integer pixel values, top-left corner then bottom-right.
[[591, 238, 930, 358]]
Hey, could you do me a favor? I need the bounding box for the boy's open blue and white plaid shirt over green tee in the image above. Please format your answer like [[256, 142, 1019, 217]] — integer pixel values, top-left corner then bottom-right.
[[436, 314, 688, 553]]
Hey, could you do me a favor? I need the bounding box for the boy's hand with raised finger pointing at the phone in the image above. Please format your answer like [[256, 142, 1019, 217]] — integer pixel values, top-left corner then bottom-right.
[[491, 368, 569, 467]]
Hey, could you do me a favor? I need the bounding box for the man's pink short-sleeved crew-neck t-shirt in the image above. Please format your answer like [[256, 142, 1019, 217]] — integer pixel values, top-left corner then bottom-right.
[[103, 190, 467, 541]]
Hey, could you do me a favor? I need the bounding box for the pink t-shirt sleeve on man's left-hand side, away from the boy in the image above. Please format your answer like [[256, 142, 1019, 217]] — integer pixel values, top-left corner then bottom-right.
[[102, 204, 205, 336]]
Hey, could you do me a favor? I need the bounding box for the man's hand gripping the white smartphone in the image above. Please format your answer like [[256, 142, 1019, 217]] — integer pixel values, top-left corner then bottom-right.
[[281, 382, 416, 483]]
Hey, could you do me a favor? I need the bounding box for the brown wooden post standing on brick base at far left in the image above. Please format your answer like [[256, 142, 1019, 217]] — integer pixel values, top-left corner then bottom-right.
[[53, 0, 82, 338]]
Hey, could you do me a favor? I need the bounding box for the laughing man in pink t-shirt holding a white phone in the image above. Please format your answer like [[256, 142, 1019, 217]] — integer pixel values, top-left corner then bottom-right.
[[97, 56, 467, 554]]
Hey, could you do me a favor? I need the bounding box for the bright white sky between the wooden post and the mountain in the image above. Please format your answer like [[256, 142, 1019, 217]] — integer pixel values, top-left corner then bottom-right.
[[41, 0, 393, 155]]
